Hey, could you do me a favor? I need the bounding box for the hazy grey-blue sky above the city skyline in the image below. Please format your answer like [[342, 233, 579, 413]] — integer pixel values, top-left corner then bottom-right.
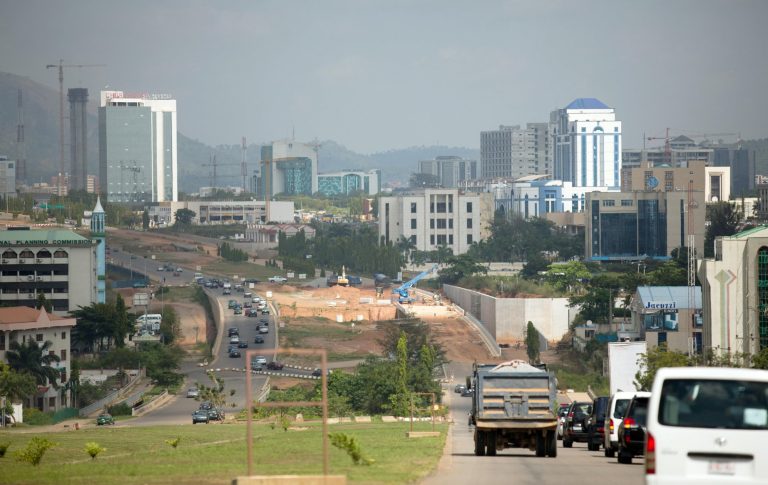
[[0, 0, 768, 153]]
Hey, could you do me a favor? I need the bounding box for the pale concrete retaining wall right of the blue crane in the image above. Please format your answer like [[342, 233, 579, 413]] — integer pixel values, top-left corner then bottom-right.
[[443, 285, 576, 343]]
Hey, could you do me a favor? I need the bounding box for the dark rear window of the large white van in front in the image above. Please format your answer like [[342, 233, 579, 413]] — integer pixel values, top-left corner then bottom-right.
[[658, 379, 768, 430]]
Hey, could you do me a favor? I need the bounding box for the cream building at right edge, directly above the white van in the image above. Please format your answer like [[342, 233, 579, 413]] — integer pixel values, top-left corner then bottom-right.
[[698, 226, 768, 355]]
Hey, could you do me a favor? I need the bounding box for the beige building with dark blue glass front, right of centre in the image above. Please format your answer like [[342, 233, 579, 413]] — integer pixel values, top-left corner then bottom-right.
[[584, 191, 706, 261]]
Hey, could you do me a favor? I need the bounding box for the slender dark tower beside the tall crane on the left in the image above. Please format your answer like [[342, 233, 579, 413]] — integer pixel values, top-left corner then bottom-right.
[[67, 88, 88, 190]]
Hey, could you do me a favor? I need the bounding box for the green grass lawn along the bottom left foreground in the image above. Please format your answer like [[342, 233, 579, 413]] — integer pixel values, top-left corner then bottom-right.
[[0, 423, 447, 485]]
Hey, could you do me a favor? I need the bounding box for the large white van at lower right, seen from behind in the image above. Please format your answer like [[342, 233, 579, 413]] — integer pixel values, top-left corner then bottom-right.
[[645, 367, 768, 485]]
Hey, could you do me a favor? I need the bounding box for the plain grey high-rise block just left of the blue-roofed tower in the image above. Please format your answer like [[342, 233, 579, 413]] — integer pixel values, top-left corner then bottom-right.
[[480, 123, 552, 179]]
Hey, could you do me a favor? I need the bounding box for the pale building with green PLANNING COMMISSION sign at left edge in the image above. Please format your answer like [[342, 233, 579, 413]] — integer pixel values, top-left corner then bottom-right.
[[0, 228, 98, 313]]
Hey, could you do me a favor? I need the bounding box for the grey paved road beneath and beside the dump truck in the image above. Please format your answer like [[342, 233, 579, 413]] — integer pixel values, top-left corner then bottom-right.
[[422, 365, 644, 485]]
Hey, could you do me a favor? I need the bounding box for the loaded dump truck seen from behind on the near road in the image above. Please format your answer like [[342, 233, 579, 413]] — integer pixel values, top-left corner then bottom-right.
[[467, 360, 557, 458]]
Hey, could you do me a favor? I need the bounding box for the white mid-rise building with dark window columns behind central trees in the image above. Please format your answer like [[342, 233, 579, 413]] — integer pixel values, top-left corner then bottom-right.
[[379, 189, 493, 254]]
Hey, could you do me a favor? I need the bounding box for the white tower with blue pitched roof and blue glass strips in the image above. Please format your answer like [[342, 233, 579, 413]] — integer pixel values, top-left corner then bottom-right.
[[550, 98, 621, 188]]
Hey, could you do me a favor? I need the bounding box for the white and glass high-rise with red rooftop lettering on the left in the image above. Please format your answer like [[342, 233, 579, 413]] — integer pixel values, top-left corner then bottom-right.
[[99, 91, 179, 202]]
